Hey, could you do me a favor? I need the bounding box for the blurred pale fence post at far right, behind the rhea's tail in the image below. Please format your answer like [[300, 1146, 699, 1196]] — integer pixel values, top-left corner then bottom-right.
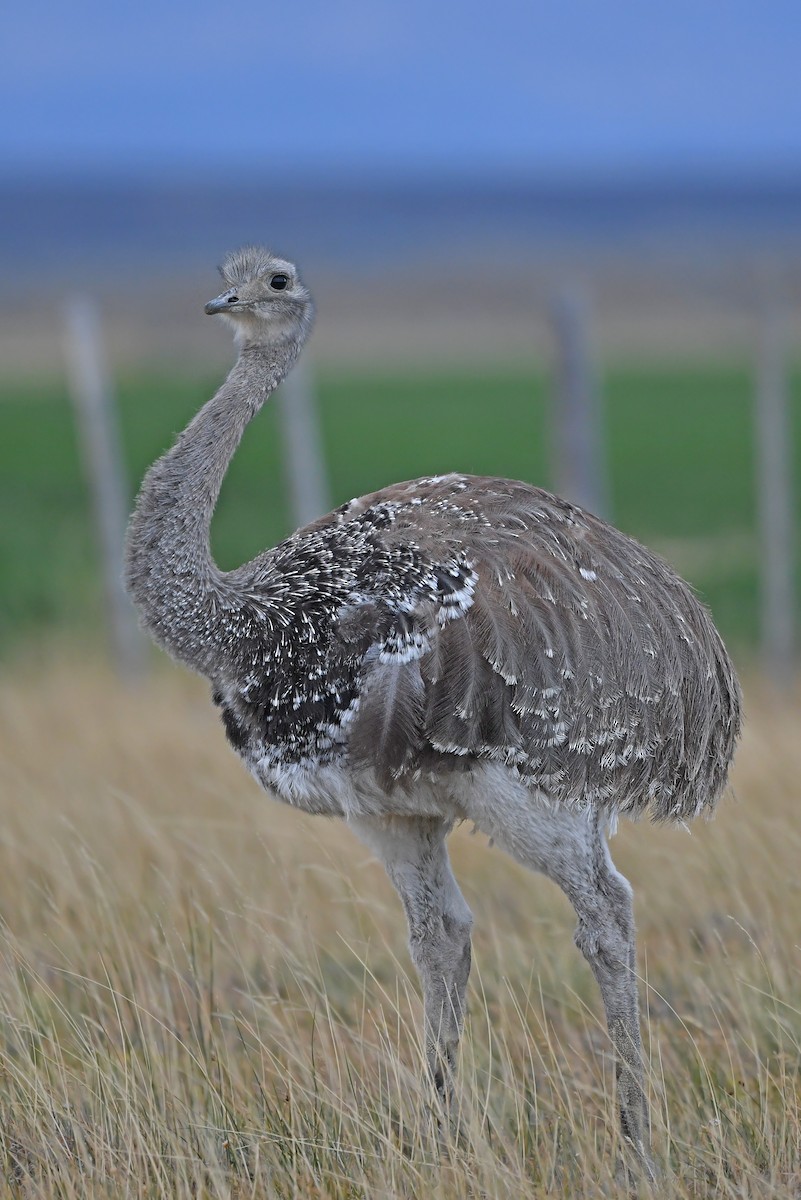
[[754, 272, 795, 686]]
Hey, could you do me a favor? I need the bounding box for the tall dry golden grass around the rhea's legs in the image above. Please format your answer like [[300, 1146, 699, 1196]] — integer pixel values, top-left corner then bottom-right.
[[0, 656, 801, 1200]]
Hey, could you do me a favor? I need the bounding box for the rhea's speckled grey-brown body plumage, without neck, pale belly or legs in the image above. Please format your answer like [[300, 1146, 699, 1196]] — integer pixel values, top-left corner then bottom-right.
[[205, 475, 739, 818]]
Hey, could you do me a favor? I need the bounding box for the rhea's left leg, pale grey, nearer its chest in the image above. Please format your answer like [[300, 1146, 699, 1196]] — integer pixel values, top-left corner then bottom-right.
[[349, 817, 472, 1128]]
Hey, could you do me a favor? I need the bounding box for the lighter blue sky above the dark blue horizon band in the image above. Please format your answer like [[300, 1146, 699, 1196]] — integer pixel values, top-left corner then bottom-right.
[[0, 0, 801, 178]]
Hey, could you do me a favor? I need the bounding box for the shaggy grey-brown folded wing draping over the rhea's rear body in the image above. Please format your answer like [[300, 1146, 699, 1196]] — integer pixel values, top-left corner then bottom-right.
[[335, 476, 739, 816]]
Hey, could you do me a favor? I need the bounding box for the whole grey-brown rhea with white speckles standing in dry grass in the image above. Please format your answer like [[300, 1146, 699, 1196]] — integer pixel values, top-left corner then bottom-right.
[[126, 247, 740, 1166]]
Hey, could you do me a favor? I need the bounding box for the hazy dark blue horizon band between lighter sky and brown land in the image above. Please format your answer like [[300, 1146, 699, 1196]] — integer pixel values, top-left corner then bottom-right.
[[0, 178, 801, 282]]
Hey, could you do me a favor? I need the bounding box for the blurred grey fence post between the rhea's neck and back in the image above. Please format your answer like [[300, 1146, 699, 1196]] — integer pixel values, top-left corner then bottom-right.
[[276, 359, 330, 528]]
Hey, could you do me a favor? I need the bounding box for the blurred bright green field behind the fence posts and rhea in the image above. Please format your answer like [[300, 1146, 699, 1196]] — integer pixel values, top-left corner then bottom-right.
[[0, 366, 801, 652]]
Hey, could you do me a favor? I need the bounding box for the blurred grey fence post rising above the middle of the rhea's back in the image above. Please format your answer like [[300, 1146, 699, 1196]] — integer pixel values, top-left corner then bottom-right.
[[550, 286, 609, 517]]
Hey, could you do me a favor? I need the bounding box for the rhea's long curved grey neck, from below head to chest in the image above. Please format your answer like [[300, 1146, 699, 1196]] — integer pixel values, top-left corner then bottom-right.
[[126, 338, 302, 674]]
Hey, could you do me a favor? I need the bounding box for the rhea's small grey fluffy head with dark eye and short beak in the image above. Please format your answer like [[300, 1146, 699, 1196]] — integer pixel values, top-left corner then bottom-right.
[[205, 246, 314, 342]]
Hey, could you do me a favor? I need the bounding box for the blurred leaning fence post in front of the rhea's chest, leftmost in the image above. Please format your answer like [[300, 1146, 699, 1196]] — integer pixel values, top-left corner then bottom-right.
[[66, 295, 144, 679]]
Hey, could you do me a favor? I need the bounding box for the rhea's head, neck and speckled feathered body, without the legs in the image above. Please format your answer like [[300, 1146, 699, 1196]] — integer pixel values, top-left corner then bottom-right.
[[127, 248, 740, 818]]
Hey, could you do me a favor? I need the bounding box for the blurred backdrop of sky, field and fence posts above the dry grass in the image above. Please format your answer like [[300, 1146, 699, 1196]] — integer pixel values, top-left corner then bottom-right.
[[0, 0, 801, 682]]
